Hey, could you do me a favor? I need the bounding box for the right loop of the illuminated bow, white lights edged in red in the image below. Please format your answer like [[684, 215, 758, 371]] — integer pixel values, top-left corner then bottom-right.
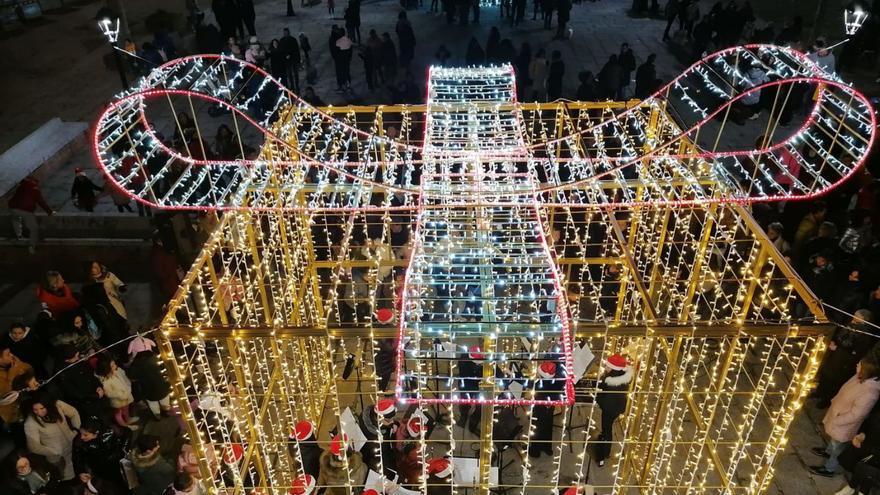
[[530, 45, 877, 207]]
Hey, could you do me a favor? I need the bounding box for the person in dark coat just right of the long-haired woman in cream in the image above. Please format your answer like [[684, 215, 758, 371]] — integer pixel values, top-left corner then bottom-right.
[[73, 419, 127, 489]]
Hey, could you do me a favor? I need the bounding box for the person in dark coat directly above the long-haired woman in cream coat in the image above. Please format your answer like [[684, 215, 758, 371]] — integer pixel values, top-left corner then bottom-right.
[[56, 344, 110, 424]]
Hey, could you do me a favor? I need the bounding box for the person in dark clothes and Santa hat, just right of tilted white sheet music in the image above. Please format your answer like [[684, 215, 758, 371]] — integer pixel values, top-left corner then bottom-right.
[[359, 399, 400, 480]]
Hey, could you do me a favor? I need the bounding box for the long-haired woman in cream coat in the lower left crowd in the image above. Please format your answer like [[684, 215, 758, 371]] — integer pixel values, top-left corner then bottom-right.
[[24, 397, 82, 481]]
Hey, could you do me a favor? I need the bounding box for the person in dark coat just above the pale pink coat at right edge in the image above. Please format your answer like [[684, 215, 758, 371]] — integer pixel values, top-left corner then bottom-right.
[[812, 309, 878, 409]]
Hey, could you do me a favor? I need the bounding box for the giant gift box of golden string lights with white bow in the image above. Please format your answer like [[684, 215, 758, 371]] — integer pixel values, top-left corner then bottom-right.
[[94, 46, 876, 493]]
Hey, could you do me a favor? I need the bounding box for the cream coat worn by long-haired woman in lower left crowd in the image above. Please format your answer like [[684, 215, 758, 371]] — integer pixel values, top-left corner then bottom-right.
[[24, 400, 81, 480]]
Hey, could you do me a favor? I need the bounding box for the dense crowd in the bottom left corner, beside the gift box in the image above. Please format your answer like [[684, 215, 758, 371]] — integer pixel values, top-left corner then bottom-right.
[[0, 261, 177, 495]]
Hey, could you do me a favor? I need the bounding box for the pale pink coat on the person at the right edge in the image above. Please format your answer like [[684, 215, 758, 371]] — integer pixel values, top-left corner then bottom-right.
[[822, 376, 880, 442]]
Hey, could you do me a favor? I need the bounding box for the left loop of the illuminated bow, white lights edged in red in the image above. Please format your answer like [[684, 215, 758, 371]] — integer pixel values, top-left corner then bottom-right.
[[94, 55, 419, 209]]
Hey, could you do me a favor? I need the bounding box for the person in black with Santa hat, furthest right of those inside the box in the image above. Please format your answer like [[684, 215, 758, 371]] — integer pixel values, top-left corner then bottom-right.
[[596, 354, 633, 467]]
